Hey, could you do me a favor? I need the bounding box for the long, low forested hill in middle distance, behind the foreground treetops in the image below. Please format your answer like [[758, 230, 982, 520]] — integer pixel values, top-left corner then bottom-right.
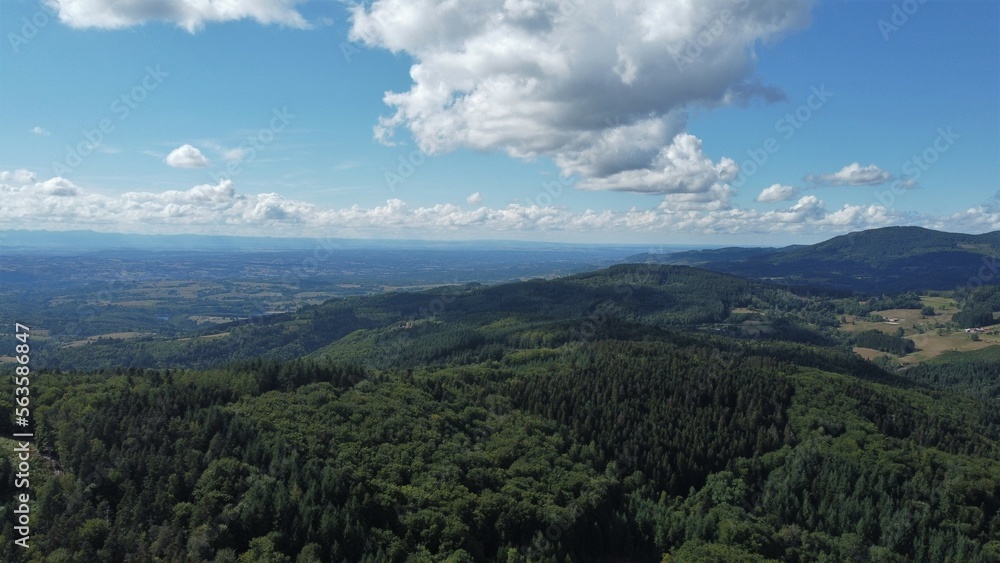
[[47, 264, 836, 370]]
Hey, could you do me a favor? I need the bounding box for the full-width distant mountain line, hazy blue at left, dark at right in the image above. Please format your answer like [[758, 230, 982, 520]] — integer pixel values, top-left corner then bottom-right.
[[0, 227, 1000, 293]]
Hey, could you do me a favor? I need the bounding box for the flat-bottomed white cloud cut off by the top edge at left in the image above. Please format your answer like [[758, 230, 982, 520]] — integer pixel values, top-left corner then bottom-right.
[[46, 0, 309, 33]]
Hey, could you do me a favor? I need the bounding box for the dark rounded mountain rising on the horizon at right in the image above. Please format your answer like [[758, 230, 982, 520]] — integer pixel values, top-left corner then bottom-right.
[[626, 227, 1000, 293]]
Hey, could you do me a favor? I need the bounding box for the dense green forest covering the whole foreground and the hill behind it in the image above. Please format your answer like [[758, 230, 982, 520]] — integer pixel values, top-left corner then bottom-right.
[[0, 265, 1000, 563]]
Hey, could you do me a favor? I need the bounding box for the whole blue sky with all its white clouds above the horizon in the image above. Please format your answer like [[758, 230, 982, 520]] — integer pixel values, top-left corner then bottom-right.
[[0, 0, 1000, 246]]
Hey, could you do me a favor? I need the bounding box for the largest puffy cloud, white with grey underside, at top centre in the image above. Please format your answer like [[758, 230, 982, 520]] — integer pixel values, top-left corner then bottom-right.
[[350, 0, 811, 200]]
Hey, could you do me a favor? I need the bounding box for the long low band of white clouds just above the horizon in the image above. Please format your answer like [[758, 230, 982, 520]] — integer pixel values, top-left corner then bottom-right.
[[0, 170, 936, 240]]
